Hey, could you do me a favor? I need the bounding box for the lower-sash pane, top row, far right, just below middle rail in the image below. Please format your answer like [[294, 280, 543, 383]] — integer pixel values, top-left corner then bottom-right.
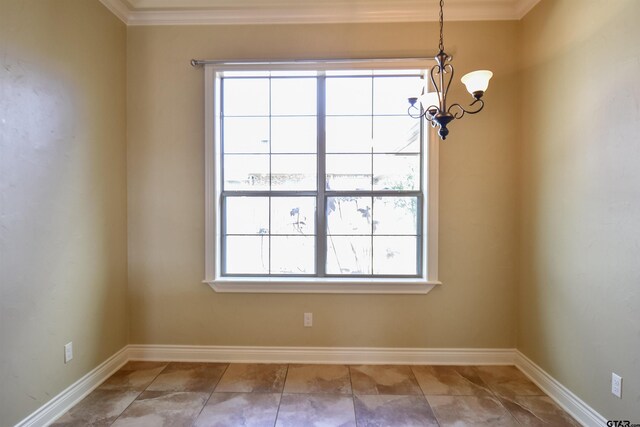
[[373, 197, 418, 235]]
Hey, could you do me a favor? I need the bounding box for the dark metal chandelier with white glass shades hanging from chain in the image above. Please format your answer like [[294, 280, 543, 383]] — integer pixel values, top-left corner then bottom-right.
[[409, 0, 493, 140]]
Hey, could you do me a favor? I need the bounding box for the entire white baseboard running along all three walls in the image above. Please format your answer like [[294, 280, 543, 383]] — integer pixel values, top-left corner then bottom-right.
[[16, 344, 606, 427]]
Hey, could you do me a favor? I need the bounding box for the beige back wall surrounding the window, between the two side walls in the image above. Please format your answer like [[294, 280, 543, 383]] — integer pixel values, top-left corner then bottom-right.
[[127, 22, 520, 348]]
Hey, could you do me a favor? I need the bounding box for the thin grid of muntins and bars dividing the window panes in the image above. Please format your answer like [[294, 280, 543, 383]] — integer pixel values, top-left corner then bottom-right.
[[220, 72, 426, 279]]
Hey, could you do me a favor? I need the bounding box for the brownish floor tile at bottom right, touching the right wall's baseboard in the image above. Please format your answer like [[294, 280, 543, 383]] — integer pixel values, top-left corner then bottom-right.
[[501, 396, 580, 427]]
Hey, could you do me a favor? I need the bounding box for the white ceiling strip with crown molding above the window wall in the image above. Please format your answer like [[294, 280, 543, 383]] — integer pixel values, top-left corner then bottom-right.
[[100, 0, 540, 25]]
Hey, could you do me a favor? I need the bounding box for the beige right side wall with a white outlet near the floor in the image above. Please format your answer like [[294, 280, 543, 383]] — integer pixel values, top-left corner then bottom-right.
[[518, 0, 640, 422]]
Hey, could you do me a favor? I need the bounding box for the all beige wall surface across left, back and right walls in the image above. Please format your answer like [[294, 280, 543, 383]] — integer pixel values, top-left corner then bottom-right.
[[8, 0, 640, 425]]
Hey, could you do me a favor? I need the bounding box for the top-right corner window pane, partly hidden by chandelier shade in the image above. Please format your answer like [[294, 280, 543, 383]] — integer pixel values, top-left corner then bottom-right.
[[373, 76, 424, 115]]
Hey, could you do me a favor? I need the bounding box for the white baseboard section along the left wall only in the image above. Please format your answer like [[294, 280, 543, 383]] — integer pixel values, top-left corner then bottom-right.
[[15, 346, 129, 427]]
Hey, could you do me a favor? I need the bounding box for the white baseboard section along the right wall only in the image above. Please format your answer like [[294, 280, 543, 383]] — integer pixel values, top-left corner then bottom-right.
[[515, 350, 607, 427]]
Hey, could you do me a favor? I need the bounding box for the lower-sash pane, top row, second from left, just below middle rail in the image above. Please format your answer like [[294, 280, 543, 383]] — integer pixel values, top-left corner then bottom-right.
[[271, 197, 316, 235]]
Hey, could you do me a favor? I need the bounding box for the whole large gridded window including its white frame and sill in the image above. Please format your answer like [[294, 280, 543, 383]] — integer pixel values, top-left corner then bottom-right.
[[205, 64, 437, 293]]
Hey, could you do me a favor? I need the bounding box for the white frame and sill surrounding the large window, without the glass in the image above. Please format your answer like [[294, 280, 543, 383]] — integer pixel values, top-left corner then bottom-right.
[[203, 59, 441, 294]]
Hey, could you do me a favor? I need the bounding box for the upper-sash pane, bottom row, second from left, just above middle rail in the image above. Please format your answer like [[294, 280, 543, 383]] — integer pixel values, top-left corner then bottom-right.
[[271, 154, 317, 191]]
